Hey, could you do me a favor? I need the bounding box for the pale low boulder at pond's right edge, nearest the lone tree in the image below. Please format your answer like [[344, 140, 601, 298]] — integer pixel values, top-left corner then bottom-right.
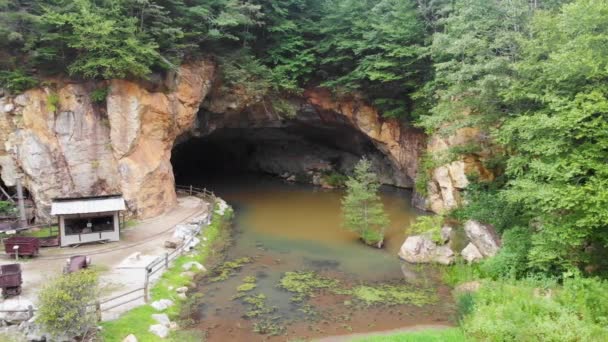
[[399, 235, 454, 265]]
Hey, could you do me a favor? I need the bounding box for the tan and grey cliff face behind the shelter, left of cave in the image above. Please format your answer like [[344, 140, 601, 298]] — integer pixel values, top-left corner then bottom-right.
[[0, 61, 215, 219]]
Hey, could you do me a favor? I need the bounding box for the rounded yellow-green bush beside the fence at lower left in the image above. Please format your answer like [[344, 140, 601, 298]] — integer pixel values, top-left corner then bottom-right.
[[37, 270, 99, 337]]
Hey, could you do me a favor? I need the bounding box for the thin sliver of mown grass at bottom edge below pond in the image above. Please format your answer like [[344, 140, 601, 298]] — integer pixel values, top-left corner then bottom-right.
[[353, 328, 467, 342]]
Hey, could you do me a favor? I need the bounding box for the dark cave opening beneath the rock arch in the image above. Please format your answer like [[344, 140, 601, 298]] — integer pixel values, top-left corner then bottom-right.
[[171, 123, 407, 186]]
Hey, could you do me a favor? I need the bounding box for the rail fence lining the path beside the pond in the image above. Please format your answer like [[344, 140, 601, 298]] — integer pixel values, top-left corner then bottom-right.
[[0, 185, 217, 321]]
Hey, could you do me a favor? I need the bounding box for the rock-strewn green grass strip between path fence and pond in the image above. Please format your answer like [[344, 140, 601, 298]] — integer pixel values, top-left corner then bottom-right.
[[101, 202, 233, 342]]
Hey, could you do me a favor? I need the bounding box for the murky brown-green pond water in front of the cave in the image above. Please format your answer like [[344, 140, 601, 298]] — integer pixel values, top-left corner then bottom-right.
[[183, 176, 453, 341]]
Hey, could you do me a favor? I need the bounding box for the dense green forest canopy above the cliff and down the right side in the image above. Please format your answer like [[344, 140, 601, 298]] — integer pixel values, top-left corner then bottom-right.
[[0, 0, 608, 277]]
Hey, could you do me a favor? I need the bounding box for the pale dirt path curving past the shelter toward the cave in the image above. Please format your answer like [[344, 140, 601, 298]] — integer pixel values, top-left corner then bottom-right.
[[0, 197, 208, 318]]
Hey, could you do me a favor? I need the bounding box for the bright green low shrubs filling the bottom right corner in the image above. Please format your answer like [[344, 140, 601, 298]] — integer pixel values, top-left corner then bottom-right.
[[463, 278, 608, 341]]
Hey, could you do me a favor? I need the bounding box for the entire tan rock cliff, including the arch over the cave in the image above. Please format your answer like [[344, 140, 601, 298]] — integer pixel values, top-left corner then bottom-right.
[[0, 61, 484, 219]]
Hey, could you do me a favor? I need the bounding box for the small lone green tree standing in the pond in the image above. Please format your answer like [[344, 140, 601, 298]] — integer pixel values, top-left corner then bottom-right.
[[342, 157, 389, 248]]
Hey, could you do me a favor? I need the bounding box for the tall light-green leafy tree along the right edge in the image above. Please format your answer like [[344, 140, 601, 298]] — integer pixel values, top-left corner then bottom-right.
[[495, 0, 608, 271]]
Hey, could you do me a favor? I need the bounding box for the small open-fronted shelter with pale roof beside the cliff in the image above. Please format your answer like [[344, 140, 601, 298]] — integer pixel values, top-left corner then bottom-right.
[[51, 195, 126, 247]]
